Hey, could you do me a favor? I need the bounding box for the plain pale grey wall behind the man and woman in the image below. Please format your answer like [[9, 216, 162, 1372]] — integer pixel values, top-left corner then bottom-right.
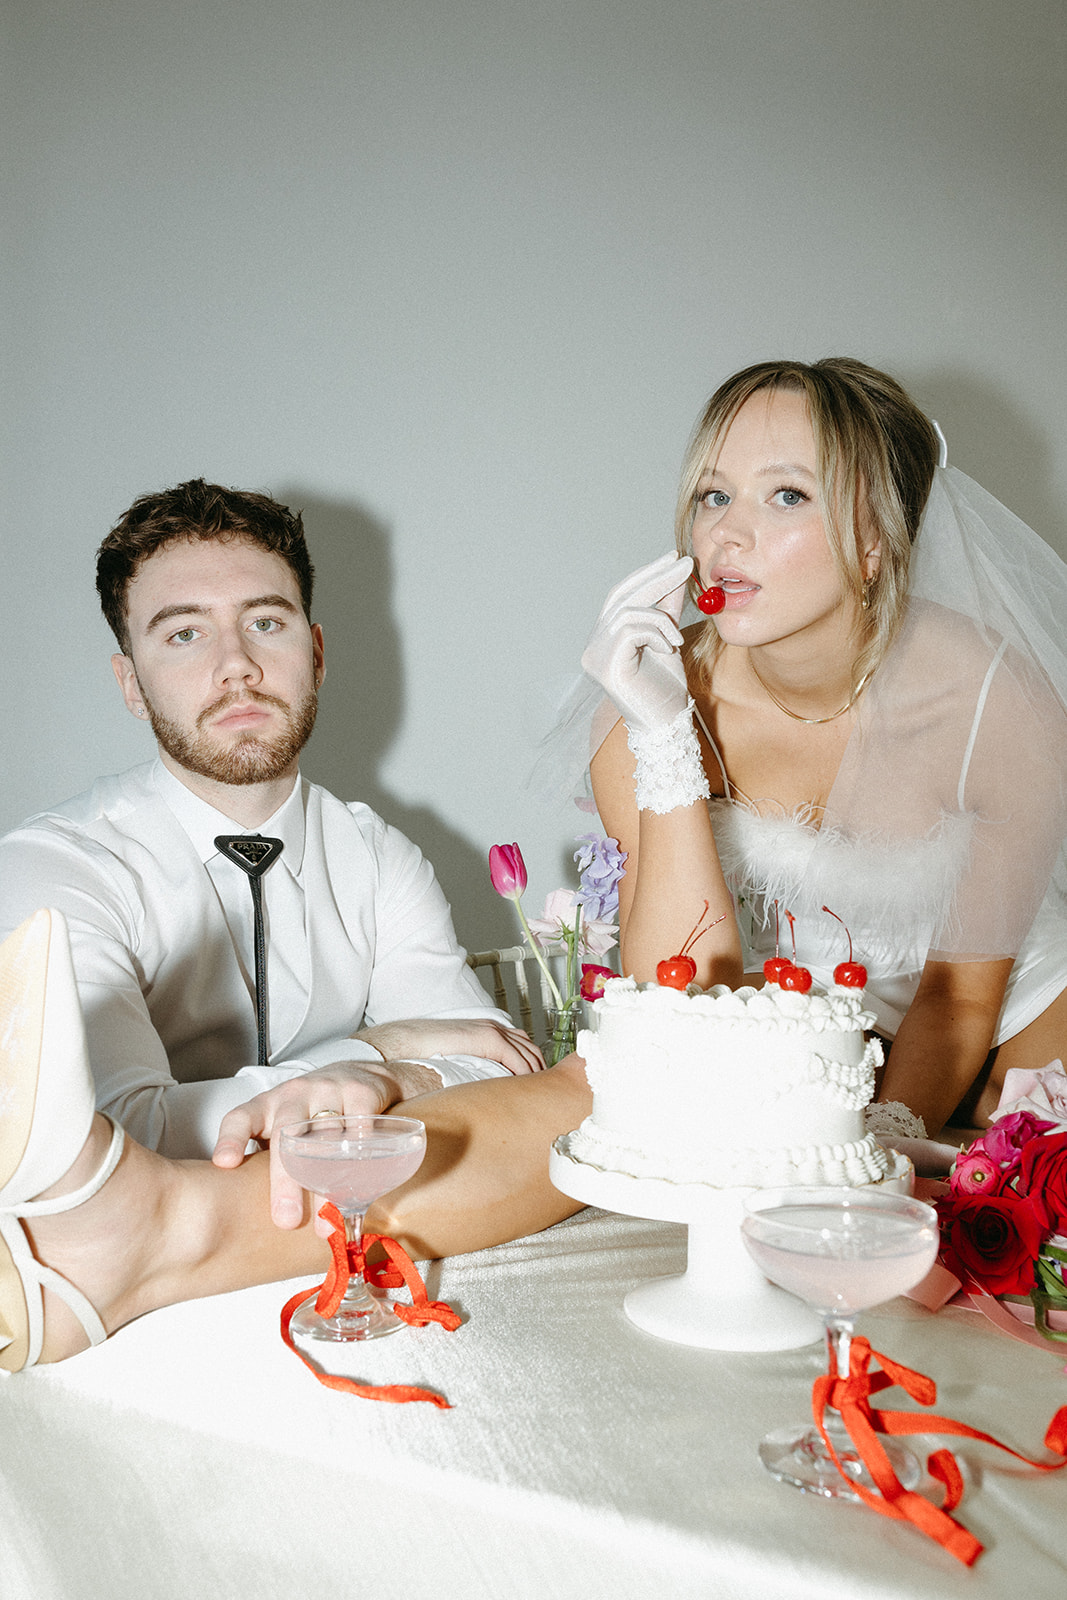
[[0, 0, 1067, 944]]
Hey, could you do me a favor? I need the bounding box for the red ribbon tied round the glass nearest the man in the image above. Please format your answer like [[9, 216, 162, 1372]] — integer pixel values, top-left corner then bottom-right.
[[282, 1200, 459, 1411]]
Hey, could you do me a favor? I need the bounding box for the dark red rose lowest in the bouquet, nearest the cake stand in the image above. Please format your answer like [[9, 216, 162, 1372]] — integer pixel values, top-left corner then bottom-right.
[[937, 1190, 1049, 1294]]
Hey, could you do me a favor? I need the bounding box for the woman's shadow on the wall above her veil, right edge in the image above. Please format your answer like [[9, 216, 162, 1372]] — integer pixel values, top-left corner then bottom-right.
[[905, 368, 1067, 560]]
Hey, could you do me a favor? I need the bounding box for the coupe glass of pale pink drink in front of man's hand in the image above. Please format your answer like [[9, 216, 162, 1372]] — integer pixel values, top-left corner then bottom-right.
[[278, 1117, 426, 1344]]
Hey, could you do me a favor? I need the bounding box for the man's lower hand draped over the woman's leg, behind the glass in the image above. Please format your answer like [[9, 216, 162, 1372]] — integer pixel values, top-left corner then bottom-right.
[[211, 1061, 442, 1227]]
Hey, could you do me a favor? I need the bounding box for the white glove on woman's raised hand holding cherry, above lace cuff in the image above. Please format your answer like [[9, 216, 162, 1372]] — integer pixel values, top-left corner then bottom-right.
[[582, 552, 693, 734]]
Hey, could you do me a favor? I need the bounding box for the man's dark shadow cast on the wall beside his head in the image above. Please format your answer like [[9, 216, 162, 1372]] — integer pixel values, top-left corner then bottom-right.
[[278, 488, 515, 949]]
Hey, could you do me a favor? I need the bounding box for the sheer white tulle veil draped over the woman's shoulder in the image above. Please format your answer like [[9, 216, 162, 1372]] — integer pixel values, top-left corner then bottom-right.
[[531, 432, 1067, 960]]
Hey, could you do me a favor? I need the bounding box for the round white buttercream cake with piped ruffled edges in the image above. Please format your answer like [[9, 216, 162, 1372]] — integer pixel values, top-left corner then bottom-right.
[[568, 978, 889, 1189]]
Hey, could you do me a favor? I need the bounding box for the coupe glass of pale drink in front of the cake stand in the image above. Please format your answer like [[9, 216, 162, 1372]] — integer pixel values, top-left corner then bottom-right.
[[741, 1189, 937, 1499]]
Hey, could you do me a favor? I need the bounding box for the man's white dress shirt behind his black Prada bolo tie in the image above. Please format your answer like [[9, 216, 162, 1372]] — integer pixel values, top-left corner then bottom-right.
[[0, 760, 509, 1157]]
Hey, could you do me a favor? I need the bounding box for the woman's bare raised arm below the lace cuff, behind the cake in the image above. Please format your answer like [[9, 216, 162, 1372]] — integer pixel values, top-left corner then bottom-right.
[[590, 720, 742, 989]]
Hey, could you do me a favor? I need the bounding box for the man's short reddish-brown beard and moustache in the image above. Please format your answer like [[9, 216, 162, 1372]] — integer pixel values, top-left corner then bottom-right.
[[141, 686, 318, 784]]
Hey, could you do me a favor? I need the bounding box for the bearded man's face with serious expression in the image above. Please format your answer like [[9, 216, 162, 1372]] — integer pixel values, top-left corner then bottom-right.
[[112, 539, 323, 784]]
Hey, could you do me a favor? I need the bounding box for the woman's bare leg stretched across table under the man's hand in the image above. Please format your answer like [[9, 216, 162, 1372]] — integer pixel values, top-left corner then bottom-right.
[[26, 1056, 589, 1362]]
